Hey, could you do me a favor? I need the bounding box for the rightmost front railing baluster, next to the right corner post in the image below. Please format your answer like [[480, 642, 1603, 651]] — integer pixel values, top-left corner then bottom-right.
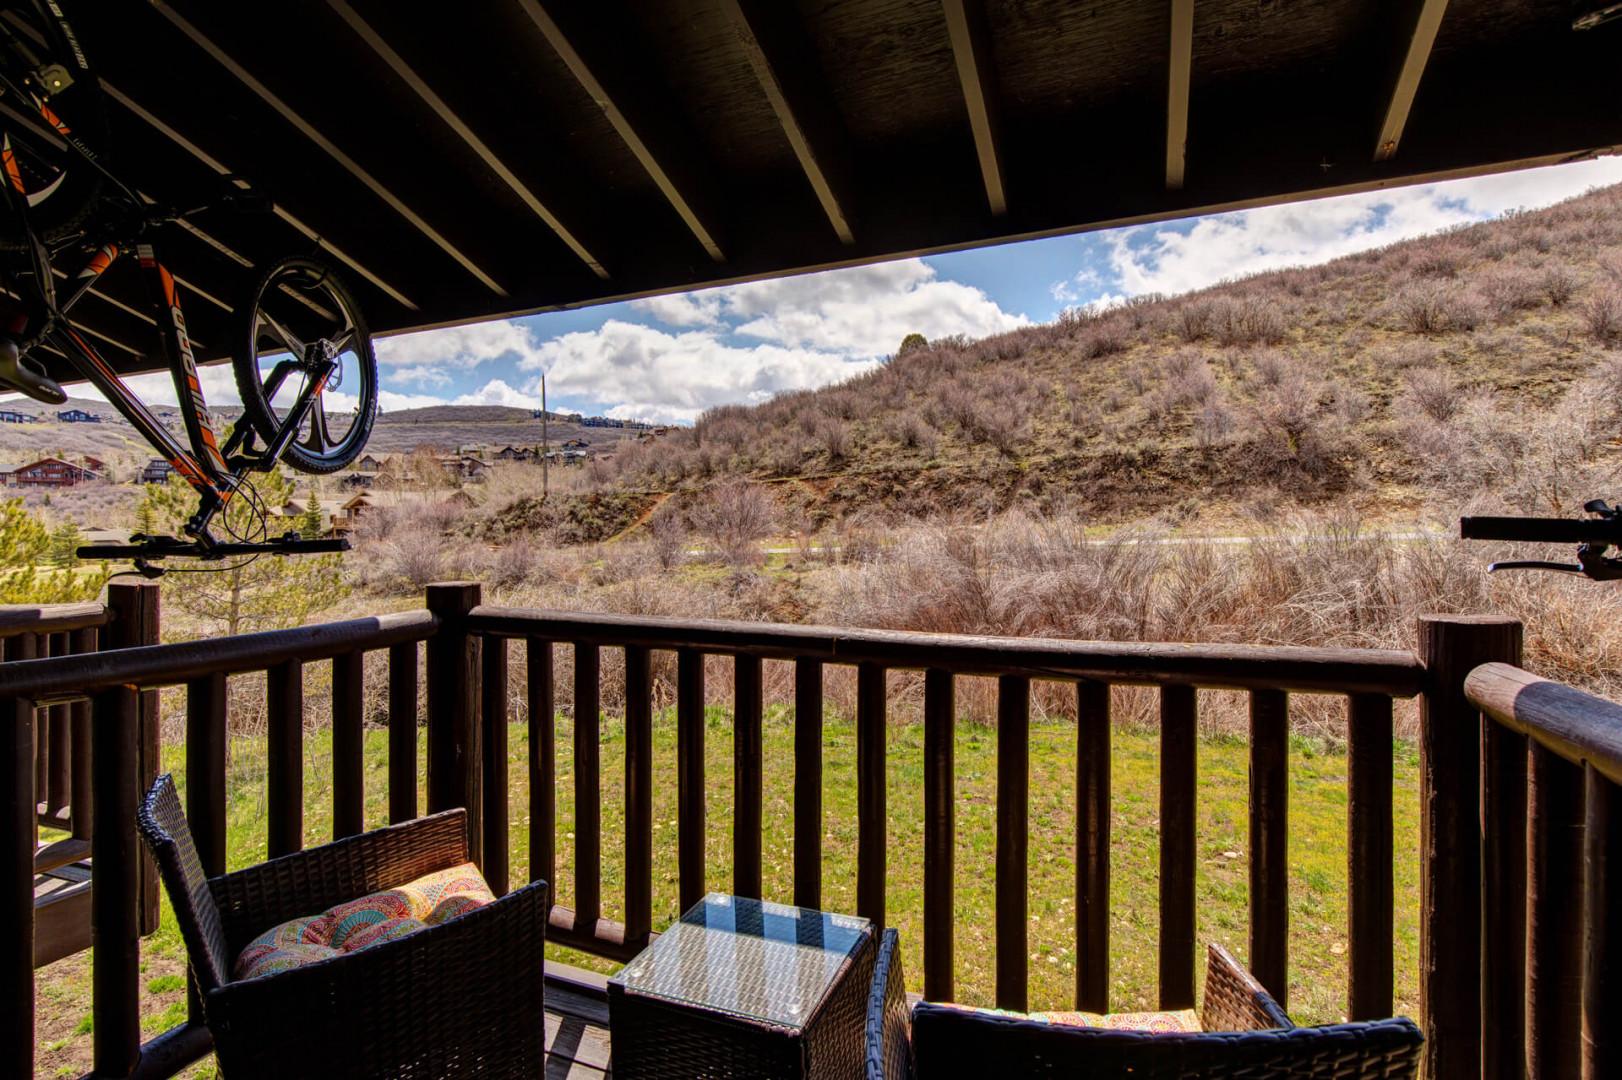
[[1346, 694, 1395, 1020]]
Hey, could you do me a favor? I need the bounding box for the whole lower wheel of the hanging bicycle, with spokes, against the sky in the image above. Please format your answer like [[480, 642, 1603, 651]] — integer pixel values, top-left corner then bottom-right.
[[232, 256, 378, 474]]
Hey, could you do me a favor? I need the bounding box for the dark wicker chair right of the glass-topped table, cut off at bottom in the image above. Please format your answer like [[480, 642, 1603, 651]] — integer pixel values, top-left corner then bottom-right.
[[868, 931, 1422, 1080]]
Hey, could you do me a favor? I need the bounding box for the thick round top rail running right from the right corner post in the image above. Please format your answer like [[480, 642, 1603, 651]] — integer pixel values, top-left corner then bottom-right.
[[1465, 663, 1622, 783]]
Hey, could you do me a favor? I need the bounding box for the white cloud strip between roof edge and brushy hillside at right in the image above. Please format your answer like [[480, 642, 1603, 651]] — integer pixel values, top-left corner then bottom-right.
[[1053, 157, 1622, 298]]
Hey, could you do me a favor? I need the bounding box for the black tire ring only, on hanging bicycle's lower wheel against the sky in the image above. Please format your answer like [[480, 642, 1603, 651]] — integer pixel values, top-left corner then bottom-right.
[[230, 255, 378, 475]]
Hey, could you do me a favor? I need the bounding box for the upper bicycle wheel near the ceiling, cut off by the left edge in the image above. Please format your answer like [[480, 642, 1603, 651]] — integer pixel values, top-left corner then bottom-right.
[[0, 3, 107, 251]]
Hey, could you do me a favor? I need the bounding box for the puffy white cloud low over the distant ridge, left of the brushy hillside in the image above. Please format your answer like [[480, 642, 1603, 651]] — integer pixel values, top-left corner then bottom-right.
[[521, 319, 876, 422]]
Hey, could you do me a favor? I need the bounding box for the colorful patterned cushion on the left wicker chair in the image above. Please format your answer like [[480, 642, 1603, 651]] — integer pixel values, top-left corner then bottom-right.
[[235, 863, 495, 979]]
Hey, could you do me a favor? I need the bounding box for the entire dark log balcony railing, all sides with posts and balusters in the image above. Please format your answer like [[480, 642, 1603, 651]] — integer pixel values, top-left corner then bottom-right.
[[0, 584, 1622, 1077]]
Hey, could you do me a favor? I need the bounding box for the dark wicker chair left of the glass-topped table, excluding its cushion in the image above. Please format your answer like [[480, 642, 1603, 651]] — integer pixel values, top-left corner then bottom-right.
[[138, 775, 548, 1080]]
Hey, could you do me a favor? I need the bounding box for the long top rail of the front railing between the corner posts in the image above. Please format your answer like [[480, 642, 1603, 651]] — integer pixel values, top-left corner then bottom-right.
[[467, 605, 1424, 697]]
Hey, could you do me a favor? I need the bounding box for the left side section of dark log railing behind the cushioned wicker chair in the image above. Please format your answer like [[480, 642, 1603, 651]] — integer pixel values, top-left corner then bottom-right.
[[0, 587, 440, 1077]]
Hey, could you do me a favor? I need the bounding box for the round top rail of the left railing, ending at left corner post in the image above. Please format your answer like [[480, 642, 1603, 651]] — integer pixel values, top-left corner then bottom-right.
[[0, 611, 440, 704]]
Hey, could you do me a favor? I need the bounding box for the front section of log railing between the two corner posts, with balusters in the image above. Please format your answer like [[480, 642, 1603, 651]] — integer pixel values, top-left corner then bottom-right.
[[466, 596, 1424, 1018]]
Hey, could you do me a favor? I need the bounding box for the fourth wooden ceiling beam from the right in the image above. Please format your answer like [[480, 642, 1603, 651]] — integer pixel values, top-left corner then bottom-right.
[[722, 0, 856, 243]]
